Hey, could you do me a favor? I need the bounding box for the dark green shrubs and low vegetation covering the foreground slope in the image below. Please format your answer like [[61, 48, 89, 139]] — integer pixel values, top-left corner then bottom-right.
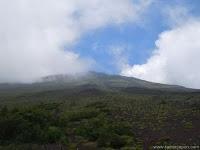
[[0, 91, 200, 150]]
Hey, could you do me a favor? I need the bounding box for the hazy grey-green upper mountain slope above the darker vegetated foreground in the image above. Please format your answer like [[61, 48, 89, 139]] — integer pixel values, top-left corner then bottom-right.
[[0, 72, 196, 94]]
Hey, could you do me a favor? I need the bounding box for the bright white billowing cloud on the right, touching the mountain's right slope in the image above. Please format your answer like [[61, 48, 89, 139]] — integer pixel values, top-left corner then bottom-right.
[[121, 19, 200, 88]]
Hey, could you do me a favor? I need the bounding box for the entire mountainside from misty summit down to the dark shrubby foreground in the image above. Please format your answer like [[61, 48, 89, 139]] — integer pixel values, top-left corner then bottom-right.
[[0, 72, 200, 150]]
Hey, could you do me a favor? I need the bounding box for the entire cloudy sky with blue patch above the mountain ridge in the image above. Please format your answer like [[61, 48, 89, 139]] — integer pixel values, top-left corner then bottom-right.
[[0, 0, 200, 88]]
